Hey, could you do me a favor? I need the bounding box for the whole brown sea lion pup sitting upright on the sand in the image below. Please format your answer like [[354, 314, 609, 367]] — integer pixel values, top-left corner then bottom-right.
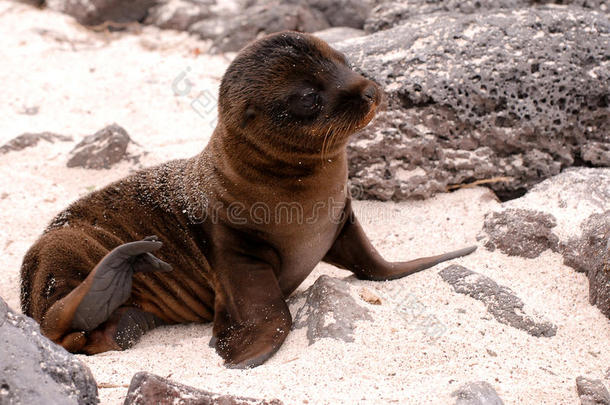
[[21, 32, 474, 367]]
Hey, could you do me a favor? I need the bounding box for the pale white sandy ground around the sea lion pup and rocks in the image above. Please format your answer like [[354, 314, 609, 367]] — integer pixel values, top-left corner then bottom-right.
[[0, 0, 610, 404]]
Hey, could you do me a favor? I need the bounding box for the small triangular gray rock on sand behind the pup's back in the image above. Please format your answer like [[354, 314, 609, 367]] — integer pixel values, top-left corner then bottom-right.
[[67, 124, 131, 169]]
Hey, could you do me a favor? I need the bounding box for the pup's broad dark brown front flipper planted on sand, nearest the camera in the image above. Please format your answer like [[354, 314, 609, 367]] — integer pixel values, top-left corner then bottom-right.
[[210, 230, 292, 368]]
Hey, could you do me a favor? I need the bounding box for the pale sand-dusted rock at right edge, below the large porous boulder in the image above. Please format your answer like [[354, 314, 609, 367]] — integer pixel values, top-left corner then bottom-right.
[[478, 167, 610, 318]]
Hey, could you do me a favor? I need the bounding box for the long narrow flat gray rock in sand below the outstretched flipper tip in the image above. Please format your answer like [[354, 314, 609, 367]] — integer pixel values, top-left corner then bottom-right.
[[439, 265, 557, 337]]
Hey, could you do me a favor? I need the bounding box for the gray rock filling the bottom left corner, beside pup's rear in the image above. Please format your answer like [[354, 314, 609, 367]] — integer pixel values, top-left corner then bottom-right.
[[0, 298, 99, 405]]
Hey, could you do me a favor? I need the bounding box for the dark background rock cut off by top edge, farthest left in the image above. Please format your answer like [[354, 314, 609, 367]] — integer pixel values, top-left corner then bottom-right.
[[46, 0, 157, 25]]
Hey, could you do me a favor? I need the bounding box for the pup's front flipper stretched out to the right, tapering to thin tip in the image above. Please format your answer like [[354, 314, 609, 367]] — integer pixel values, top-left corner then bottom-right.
[[322, 200, 477, 281]]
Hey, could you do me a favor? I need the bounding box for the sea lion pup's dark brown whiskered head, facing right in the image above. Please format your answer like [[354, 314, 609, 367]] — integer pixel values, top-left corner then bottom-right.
[[219, 32, 381, 155]]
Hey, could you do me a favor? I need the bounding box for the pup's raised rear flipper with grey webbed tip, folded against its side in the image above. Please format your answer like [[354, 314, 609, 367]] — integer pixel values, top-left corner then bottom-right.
[[41, 236, 172, 342]]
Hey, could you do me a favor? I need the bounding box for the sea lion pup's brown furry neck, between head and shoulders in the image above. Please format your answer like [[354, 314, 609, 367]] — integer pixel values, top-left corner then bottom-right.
[[185, 121, 347, 210]]
